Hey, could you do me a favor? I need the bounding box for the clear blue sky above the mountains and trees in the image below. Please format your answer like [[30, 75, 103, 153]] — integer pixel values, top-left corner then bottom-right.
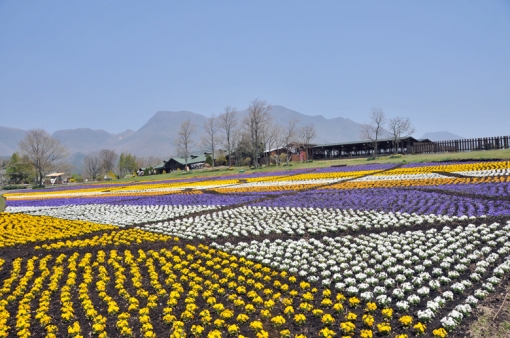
[[0, 0, 510, 137]]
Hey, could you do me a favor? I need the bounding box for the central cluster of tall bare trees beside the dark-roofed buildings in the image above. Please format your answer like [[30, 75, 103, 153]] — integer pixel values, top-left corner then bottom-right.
[[174, 99, 317, 169]]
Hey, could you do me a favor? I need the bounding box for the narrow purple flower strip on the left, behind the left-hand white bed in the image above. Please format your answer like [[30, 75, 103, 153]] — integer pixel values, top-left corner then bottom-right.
[[6, 194, 261, 207]]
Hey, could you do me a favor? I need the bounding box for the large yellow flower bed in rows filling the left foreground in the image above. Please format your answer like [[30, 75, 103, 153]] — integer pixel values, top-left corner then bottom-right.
[[0, 245, 450, 338]]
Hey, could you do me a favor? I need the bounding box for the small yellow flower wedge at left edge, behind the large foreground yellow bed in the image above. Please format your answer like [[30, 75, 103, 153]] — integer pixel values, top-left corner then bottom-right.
[[0, 212, 117, 247]]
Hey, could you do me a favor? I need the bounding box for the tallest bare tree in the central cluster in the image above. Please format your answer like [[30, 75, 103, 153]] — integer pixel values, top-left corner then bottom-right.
[[244, 99, 272, 168]]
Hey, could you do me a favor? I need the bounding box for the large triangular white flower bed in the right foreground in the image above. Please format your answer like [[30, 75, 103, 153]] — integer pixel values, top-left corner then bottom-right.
[[214, 222, 510, 326]]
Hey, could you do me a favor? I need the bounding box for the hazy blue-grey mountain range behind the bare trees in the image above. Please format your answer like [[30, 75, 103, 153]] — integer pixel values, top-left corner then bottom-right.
[[0, 106, 361, 158]]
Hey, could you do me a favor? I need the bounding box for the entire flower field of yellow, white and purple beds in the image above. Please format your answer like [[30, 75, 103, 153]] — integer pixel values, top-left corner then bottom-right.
[[0, 161, 510, 338]]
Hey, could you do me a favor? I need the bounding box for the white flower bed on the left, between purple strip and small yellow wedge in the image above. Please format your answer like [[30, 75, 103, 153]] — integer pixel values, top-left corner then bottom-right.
[[6, 204, 219, 226]]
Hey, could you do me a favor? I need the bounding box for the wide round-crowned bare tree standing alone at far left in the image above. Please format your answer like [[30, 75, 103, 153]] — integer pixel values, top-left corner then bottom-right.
[[18, 129, 68, 185]]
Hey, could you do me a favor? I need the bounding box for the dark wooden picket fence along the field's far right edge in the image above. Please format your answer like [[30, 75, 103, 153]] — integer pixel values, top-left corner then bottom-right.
[[413, 136, 510, 154]]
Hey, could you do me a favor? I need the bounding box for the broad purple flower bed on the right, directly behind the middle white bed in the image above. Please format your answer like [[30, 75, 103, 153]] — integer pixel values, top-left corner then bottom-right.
[[250, 188, 510, 216]]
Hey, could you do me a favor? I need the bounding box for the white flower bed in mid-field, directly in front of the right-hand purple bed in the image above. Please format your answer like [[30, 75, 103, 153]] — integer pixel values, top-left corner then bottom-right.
[[138, 206, 454, 239]]
